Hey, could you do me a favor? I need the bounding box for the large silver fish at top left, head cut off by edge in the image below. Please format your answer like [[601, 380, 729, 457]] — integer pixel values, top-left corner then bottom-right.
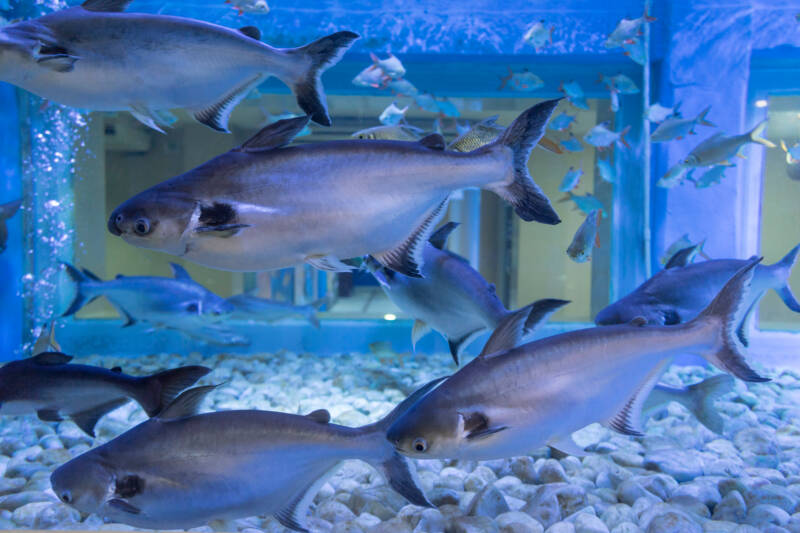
[[0, 0, 358, 131]]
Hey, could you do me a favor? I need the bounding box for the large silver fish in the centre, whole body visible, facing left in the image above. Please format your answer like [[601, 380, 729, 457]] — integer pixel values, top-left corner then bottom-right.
[[108, 100, 560, 276]]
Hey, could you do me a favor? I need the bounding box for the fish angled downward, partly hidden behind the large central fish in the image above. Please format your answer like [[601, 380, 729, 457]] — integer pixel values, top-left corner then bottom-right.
[[366, 222, 568, 364]]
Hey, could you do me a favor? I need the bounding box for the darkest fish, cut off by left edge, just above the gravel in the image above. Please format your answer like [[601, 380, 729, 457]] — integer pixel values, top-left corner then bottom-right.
[[0, 352, 211, 437]]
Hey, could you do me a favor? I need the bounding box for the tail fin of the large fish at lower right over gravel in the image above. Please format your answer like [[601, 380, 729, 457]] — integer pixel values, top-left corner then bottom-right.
[[683, 258, 769, 382]]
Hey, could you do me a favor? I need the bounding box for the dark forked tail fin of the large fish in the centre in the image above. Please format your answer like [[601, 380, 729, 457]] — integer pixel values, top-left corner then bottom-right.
[[486, 98, 561, 224]]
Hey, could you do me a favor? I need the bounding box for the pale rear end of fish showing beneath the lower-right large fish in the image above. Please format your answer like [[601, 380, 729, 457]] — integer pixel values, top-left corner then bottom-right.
[[642, 374, 736, 435]]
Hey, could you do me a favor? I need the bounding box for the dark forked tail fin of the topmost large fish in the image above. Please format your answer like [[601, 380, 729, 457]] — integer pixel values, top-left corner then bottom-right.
[[290, 31, 360, 126]]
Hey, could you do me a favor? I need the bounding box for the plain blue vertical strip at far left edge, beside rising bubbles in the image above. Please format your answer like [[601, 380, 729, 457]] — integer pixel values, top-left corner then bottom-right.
[[0, 83, 25, 360]]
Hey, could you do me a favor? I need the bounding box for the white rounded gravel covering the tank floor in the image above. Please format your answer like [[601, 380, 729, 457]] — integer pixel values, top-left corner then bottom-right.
[[0, 352, 800, 533]]
